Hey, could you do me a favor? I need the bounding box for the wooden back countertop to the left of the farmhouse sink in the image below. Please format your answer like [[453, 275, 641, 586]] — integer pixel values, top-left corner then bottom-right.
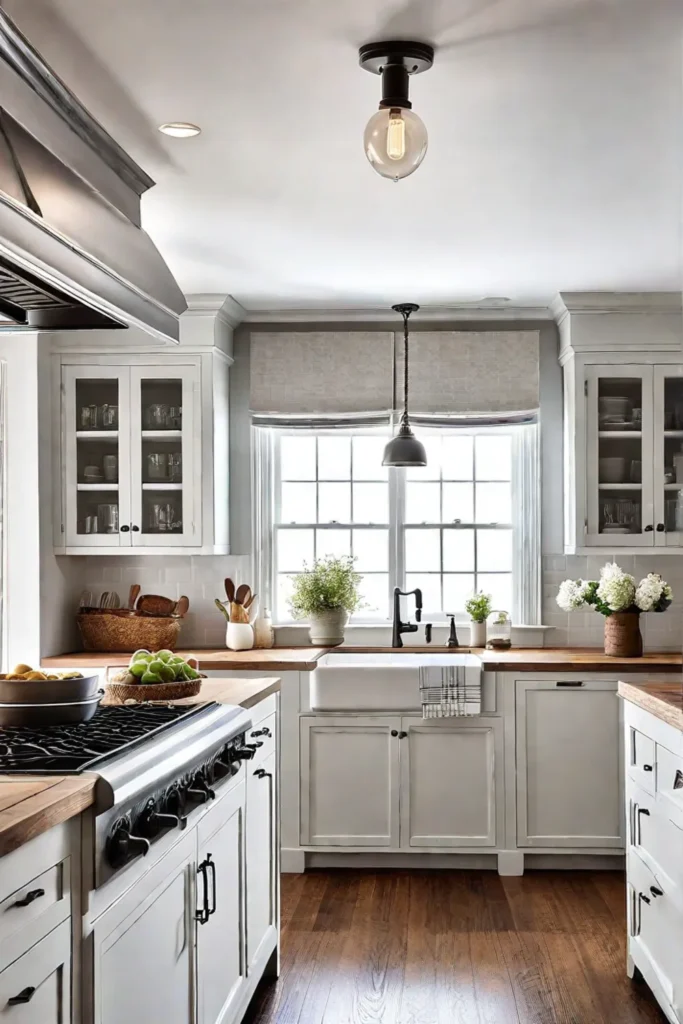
[[40, 647, 326, 672]]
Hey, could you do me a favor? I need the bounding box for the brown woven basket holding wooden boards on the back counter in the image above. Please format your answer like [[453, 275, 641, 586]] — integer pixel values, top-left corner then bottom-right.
[[76, 611, 181, 654]]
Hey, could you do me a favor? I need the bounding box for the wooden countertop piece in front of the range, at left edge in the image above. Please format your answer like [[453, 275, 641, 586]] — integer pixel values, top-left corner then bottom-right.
[[0, 775, 95, 857]]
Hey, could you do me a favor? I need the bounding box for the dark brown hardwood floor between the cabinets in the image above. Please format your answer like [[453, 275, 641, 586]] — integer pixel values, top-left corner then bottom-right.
[[247, 870, 666, 1024]]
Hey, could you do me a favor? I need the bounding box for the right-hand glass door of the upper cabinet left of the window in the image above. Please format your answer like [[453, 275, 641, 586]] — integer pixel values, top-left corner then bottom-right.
[[130, 366, 202, 548]]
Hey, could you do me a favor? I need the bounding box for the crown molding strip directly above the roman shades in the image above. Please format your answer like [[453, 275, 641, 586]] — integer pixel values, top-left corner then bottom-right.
[[244, 302, 552, 324]]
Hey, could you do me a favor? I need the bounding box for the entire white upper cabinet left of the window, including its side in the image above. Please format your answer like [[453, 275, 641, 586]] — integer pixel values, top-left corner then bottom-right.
[[55, 354, 228, 554]]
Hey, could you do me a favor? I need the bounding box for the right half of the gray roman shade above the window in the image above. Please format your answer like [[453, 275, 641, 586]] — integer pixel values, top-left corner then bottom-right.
[[396, 331, 539, 417]]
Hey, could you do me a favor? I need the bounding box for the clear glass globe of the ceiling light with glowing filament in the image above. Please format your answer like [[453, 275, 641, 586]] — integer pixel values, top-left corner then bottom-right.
[[364, 106, 428, 181]]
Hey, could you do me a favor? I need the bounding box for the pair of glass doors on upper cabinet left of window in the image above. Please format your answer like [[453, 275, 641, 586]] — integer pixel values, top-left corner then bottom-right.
[[62, 366, 202, 549]]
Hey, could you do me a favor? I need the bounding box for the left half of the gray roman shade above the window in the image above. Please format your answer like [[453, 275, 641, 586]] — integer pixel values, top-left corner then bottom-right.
[[250, 331, 393, 423]]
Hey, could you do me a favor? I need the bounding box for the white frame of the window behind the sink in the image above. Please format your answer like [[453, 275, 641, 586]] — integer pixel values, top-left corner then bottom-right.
[[254, 424, 541, 626]]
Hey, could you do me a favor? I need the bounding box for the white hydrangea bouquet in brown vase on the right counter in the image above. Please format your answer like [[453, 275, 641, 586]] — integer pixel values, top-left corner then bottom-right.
[[557, 562, 674, 657]]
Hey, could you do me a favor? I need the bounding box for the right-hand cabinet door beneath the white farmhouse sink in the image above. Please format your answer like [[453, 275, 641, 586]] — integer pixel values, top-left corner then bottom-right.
[[400, 717, 503, 848]]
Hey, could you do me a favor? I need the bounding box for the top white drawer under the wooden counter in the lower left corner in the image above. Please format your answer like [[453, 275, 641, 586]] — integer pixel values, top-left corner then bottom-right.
[[0, 860, 71, 964]]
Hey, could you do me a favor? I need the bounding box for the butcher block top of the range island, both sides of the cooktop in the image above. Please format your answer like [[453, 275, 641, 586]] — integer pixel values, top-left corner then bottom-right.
[[0, 677, 280, 857]]
